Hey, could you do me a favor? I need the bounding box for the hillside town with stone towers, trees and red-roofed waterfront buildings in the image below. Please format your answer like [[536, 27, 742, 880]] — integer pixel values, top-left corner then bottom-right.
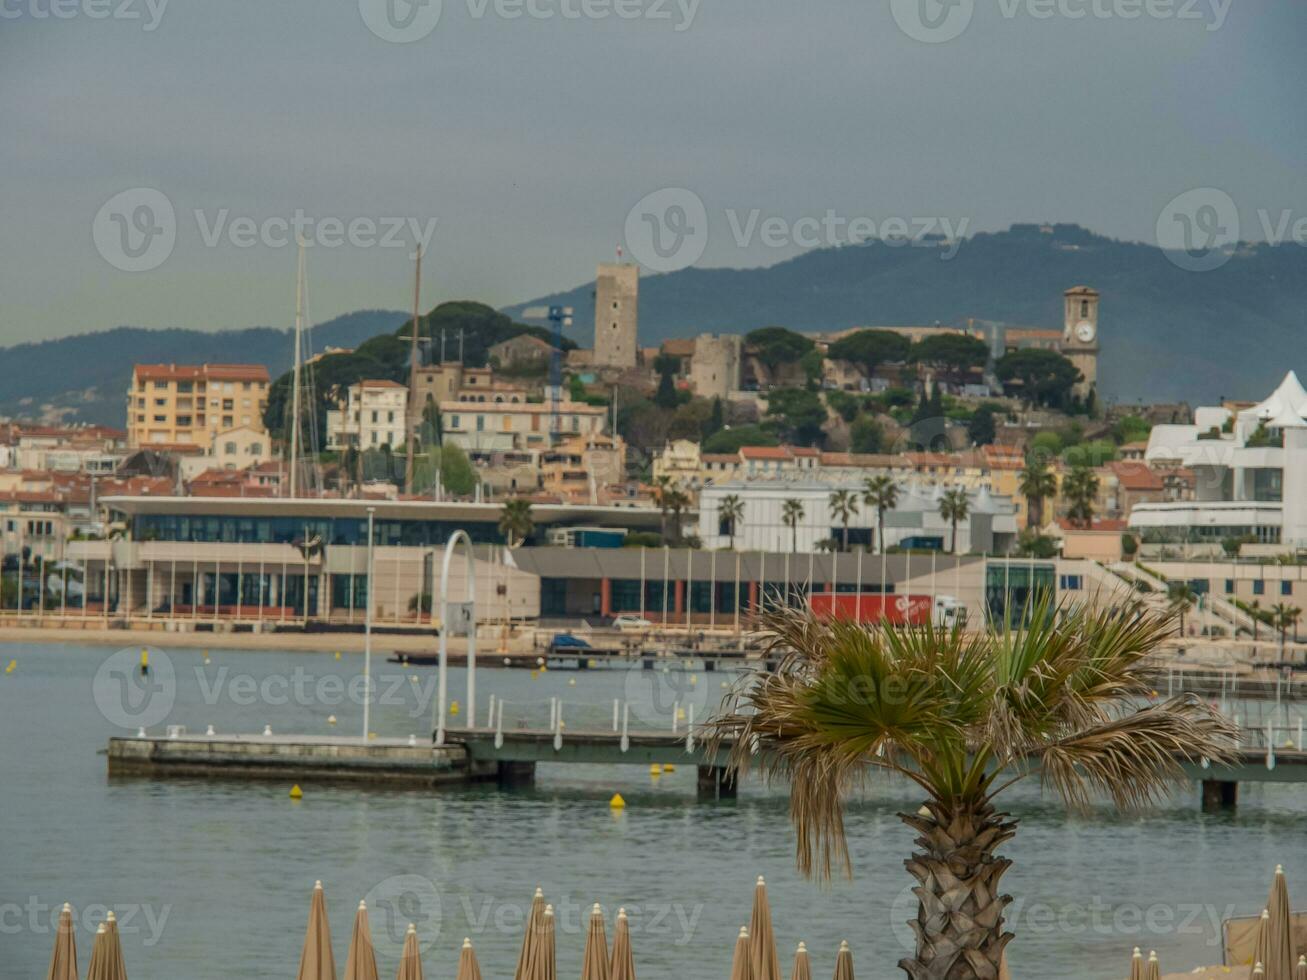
[[0, 264, 1307, 645]]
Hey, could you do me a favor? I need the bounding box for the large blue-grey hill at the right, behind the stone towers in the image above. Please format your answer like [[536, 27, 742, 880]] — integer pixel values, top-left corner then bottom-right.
[[505, 225, 1307, 402]]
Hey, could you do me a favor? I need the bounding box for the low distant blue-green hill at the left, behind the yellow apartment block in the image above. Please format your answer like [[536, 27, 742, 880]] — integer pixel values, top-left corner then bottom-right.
[[0, 310, 408, 427]]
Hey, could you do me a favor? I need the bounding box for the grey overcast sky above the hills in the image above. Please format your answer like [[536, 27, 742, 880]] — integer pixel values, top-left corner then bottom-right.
[[0, 0, 1307, 345]]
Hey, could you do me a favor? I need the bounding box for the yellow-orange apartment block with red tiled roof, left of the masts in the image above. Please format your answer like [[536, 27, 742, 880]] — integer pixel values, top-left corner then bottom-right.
[[127, 365, 271, 449]]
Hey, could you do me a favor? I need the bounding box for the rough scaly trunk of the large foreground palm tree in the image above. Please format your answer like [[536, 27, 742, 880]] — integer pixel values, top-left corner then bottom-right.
[[898, 801, 1017, 980]]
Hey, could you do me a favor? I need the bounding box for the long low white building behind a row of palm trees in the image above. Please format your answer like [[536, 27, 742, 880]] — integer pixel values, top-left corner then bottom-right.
[[699, 480, 1019, 554]]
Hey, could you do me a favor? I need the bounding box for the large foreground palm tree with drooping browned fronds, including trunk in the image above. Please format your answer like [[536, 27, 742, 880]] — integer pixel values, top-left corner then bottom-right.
[[710, 601, 1238, 980]]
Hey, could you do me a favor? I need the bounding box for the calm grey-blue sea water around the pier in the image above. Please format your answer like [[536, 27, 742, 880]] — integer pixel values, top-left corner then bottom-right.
[[0, 645, 1307, 980]]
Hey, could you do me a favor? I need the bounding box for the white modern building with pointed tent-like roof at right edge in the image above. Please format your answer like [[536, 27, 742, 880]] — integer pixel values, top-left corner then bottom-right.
[[1129, 371, 1307, 550]]
